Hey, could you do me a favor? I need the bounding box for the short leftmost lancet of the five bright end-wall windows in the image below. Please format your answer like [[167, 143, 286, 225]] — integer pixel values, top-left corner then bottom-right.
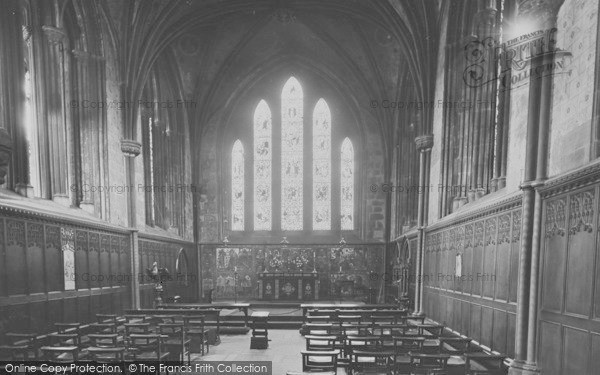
[[231, 139, 244, 231]]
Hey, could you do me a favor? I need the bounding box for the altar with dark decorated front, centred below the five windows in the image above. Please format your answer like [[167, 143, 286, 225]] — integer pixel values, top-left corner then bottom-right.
[[258, 272, 319, 301]]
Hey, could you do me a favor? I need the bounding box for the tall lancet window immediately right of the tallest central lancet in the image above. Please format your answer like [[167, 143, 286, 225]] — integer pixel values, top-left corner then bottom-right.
[[313, 99, 331, 230]]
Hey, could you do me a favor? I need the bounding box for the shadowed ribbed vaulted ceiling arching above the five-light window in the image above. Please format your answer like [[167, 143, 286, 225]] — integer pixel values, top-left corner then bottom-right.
[[103, 0, 444, 157]]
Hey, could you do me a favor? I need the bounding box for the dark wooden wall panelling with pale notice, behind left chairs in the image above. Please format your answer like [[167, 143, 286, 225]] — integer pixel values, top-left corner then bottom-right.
[[0, 212, 130, 344]]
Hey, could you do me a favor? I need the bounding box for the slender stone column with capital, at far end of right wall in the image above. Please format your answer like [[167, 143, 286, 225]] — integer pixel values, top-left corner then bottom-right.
[[414, 134, 433, 316]]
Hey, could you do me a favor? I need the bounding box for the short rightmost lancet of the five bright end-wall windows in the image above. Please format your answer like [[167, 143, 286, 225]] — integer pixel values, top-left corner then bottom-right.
[[340, 138, 354, 230]]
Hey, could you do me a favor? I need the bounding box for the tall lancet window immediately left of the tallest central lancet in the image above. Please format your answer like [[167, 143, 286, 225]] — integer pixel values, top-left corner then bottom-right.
[[254, 100, 273, 230]]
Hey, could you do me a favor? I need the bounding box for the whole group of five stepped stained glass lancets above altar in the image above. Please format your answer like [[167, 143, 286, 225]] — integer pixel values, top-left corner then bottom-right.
[[229, 77, 356, 232]]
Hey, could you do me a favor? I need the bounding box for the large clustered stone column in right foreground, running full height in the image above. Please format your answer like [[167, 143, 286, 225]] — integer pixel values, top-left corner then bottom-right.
[[509, 0, 563, 374]]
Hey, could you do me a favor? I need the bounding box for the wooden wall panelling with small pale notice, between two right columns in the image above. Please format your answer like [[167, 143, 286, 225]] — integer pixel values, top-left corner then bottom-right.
[[423, 203, 521, 356]]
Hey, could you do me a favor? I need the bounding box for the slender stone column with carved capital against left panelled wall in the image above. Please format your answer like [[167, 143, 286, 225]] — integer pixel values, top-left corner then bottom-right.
[[121, 139, 142, 309]]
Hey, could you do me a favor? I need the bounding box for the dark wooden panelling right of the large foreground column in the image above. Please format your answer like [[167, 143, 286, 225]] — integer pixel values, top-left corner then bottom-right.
[[538, 179, 600, 374]]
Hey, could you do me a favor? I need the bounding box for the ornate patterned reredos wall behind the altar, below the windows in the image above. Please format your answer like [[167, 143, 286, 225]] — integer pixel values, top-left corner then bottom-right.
[[201, 244, 385, 300]]
